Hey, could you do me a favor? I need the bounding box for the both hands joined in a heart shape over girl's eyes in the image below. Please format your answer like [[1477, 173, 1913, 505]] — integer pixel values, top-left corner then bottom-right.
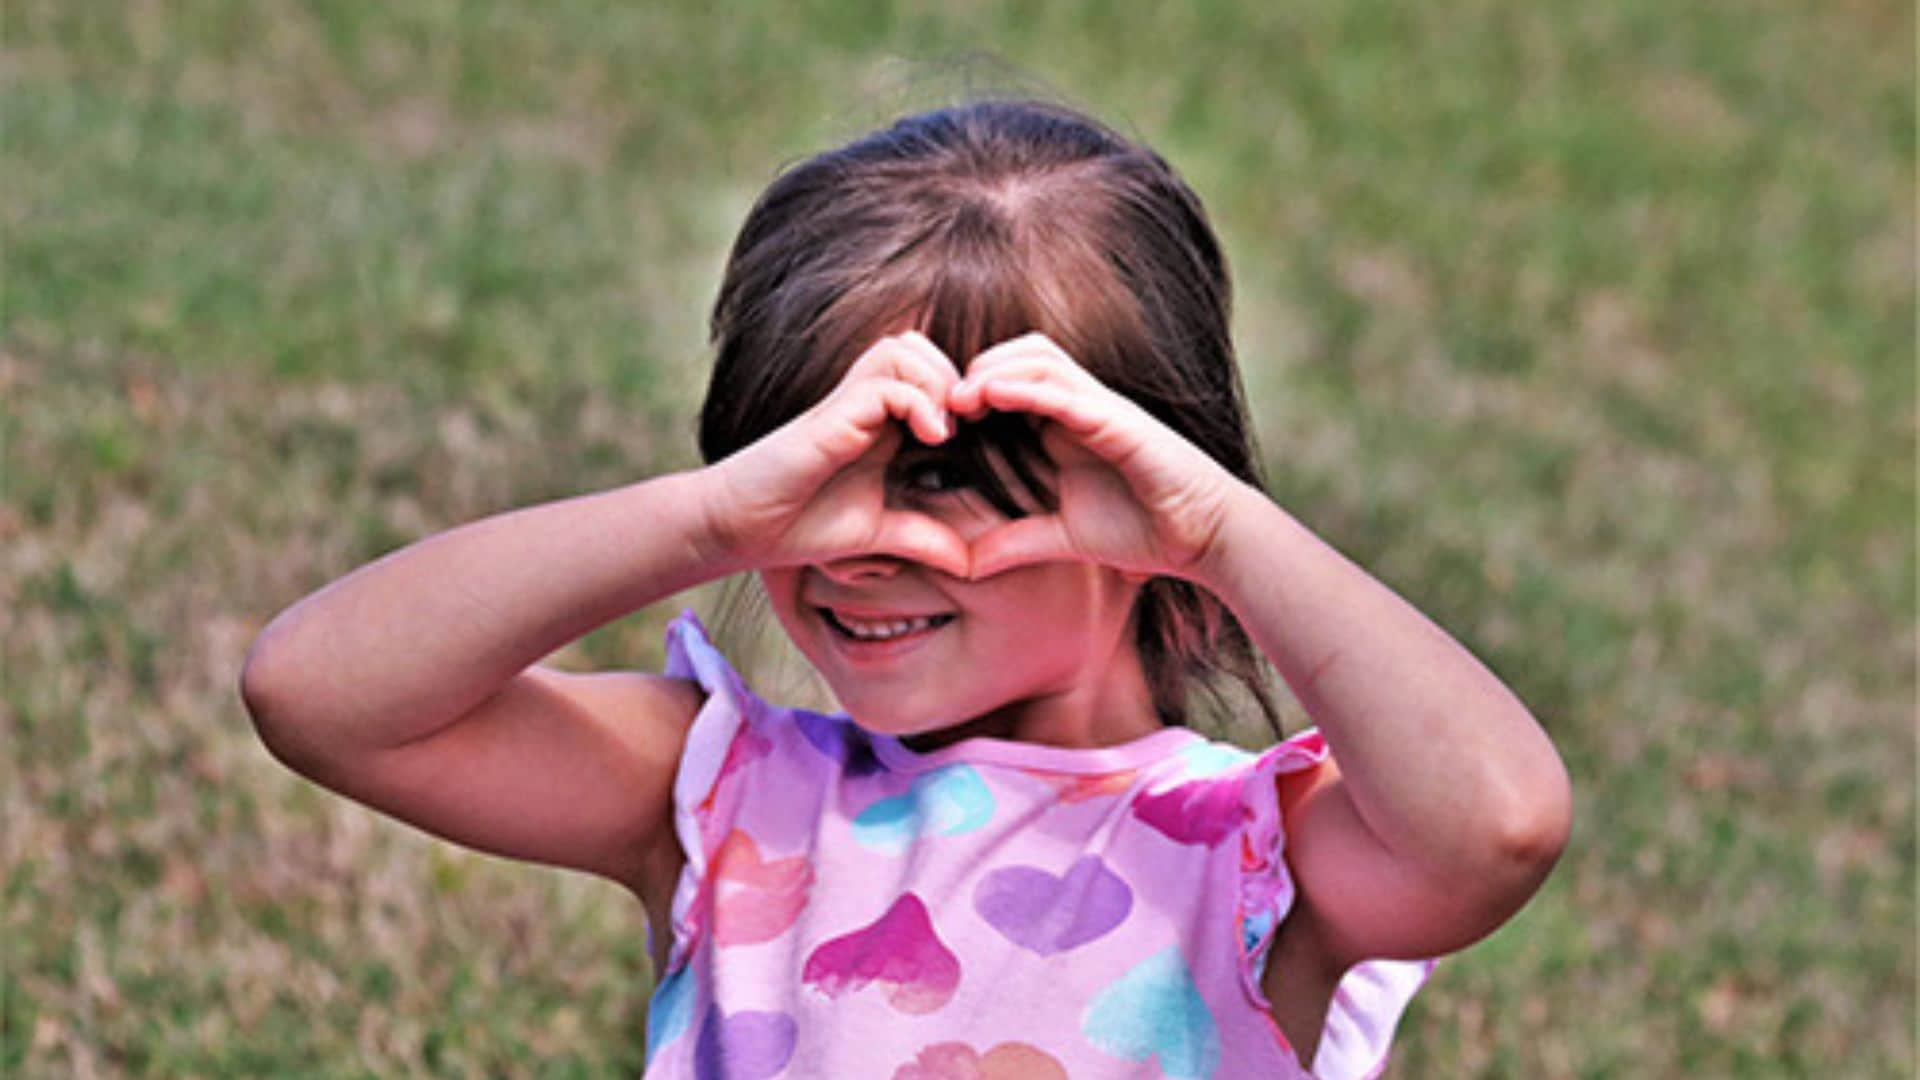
[[703, 331, 1244, 580]]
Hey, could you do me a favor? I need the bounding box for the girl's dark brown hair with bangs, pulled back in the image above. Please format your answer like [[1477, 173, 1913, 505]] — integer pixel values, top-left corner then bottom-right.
[[699, 98, 1281, 734]]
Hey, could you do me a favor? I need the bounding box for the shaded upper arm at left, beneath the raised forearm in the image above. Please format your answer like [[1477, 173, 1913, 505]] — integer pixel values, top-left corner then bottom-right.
[[259, 665, 705, 896]]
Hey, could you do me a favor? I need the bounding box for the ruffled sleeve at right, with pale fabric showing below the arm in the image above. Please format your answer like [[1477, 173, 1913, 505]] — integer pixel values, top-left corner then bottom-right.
[[1240, 728, 1434, 1080]]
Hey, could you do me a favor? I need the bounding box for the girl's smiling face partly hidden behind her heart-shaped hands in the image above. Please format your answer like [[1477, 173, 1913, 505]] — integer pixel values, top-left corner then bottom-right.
[[760, 438, 1160, 748]]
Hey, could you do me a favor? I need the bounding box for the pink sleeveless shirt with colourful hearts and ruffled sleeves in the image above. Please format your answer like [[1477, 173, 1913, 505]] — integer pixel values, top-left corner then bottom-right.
[[647, 609, 1434, 1080]]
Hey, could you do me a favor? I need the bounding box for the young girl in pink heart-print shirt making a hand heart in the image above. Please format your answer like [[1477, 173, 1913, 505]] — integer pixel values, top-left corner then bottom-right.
[[242, 102, 1571, 1080]]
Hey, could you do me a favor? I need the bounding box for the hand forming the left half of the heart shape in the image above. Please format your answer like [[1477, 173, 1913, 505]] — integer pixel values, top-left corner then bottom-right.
[[703, 331, 970, 577]]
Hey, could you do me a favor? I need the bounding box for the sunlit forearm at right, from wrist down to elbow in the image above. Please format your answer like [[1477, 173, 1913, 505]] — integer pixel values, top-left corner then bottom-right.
[[1200, 478, 1569, 874]]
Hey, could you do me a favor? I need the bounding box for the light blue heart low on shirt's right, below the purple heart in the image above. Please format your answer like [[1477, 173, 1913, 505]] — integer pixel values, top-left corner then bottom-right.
[[1081, 945, 1219, 1078]]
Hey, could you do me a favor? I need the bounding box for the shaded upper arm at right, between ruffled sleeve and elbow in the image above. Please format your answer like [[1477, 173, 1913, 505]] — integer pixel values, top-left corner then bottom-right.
[[1275, 757, 1546, 969]]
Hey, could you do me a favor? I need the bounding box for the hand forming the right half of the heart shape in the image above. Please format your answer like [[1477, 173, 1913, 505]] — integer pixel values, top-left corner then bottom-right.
[[947, 332, 1244, 578]]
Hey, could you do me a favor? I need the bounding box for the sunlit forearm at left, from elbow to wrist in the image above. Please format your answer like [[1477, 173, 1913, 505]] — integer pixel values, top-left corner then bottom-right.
[[242, 471, 735, 751]]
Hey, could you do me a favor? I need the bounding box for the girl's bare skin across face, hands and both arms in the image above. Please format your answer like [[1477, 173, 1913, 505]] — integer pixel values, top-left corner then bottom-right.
[[242, 315, 1572, 1061]]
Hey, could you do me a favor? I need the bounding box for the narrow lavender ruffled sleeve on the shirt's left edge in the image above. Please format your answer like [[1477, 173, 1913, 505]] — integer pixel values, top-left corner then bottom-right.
[[666, 607, 772, 972]]
